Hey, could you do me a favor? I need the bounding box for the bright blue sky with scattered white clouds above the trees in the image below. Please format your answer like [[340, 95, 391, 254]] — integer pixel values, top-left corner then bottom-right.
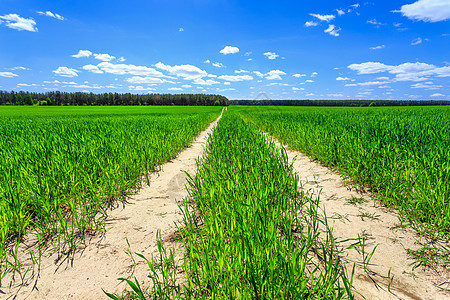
[[0, 0, 450, 100]]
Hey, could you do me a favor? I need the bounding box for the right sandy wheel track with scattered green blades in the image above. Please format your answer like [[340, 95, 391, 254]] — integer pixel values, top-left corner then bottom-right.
[[274, 140, 450, 299]]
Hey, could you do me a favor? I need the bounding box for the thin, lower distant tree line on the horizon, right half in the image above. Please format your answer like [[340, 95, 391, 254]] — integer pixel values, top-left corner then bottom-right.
[[230, 100, 450, 107]]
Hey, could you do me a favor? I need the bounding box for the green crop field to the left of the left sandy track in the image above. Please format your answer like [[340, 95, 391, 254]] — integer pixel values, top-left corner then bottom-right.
[[0, 106, 221, 278]]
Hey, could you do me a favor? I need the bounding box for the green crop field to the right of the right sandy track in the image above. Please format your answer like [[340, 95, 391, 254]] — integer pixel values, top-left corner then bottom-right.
[[236, 106, 450, 236]]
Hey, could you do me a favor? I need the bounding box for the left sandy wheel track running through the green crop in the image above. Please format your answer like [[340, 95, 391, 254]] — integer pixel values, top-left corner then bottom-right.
[[0, 115, 222, 299]]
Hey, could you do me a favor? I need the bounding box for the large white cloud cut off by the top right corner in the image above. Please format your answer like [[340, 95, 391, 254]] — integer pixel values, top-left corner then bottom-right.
[[395, 0, 450, 22]]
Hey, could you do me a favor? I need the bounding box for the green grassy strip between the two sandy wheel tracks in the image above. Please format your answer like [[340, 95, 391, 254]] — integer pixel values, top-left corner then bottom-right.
[[108, 113, 353, 299]]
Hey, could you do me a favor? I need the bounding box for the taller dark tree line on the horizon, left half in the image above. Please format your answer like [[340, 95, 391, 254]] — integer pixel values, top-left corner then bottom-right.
[[0, 91, 229, 106]]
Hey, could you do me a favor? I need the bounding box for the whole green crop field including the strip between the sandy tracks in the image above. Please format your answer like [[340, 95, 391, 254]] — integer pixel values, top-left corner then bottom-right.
[[0, 106, 450, 299]]
